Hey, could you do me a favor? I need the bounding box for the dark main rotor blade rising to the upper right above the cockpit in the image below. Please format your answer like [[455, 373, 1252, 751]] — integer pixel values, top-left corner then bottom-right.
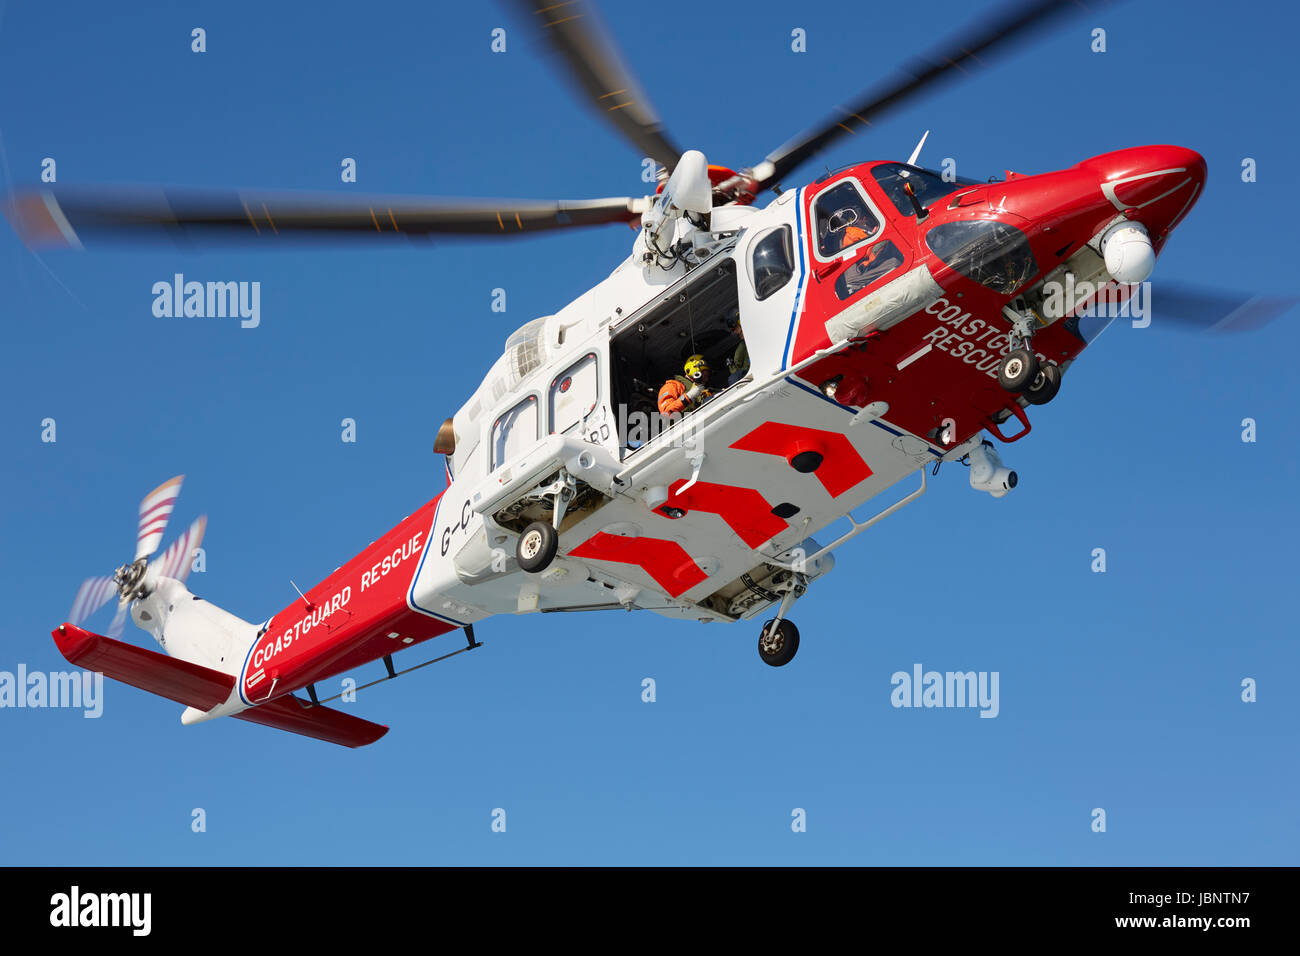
[[749, 0, 1110, 189]]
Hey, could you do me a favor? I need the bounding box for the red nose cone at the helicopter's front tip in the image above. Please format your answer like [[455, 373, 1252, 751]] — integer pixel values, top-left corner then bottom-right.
[[1079, 146, 1206, 235]]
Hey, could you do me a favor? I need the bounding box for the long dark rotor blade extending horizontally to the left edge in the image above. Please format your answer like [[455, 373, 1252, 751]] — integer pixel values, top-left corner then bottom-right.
[[4, 189, 647, 248]]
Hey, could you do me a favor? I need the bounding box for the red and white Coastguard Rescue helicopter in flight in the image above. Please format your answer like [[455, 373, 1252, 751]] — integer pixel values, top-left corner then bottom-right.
[[8, 0, 1289, 747]]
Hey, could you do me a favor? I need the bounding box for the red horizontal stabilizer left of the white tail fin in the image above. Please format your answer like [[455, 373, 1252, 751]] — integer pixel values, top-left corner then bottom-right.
[[53, 624, 235, 710]]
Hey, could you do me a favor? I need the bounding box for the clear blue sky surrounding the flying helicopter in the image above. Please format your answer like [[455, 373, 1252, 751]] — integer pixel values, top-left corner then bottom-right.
[[0, 0, 1300, 865]]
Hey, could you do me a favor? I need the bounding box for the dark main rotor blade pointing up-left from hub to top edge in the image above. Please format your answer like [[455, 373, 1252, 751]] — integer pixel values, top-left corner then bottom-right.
[[514, 0, 681, 173]]
